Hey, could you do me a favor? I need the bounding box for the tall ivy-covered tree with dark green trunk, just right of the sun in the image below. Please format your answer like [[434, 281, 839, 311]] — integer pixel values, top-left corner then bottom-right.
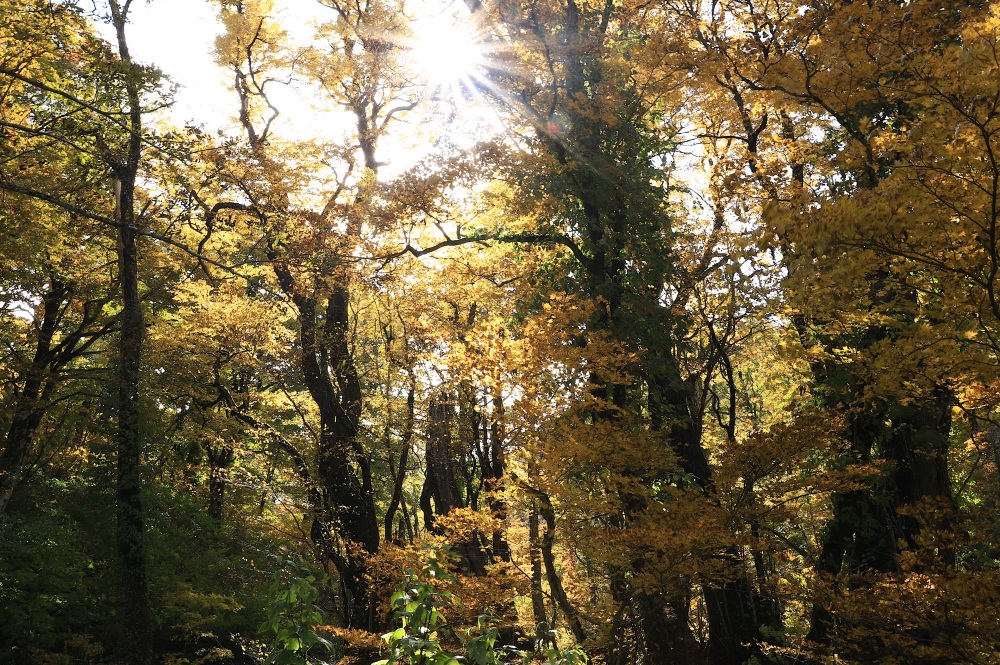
[[460, 2, 780, 662]]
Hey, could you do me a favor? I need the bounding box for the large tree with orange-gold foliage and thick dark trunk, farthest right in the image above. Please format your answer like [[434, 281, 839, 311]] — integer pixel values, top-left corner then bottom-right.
[[656, 3, 1000, 658]]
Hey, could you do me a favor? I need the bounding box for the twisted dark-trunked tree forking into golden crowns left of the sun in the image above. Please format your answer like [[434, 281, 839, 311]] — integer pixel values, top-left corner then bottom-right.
[[218, 3, 428, 627]]
